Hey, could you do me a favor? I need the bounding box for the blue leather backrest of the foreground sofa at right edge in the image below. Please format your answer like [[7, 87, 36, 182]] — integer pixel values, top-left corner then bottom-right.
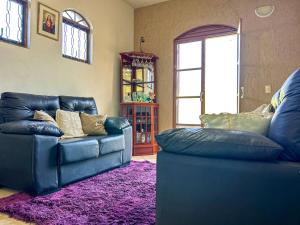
[[268, 69, 300, 161]]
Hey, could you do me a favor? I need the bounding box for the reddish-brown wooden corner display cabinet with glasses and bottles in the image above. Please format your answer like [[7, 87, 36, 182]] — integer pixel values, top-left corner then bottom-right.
[[120, 52, 158, 156]]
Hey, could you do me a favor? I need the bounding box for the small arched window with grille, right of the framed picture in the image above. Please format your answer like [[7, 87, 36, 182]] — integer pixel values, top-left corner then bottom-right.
[[62, 10, 91, 63]]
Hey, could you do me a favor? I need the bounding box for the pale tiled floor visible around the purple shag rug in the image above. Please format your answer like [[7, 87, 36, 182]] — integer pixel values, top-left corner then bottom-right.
[[0, 155, 156, 225]]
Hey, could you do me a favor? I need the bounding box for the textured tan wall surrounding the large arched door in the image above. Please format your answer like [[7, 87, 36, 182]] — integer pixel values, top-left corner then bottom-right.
[[135, 0, 300, 130]]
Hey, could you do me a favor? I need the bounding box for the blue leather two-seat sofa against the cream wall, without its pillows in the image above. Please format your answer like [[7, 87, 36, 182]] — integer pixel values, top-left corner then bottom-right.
[[0, 92, 132, 194]]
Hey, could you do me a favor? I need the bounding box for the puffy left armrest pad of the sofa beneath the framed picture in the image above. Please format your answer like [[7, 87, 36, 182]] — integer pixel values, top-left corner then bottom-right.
[[0, 120, 64, 137]]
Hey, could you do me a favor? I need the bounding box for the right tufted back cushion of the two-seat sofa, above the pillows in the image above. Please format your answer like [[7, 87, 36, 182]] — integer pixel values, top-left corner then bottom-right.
[[59, 96, 98, 115]]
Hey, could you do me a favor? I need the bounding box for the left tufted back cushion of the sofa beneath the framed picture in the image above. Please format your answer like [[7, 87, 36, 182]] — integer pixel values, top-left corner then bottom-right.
[[0, 92, 59, 123]]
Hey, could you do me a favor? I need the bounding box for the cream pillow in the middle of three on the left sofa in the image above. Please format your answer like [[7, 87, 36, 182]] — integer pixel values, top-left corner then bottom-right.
[[56, 109, 86, 138]]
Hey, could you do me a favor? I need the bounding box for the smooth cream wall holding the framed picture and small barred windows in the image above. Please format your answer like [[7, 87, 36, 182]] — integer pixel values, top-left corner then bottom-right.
[[0, 0, 134, 115]]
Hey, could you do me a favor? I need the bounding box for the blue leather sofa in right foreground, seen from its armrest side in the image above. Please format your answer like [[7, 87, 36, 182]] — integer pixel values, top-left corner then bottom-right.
[[156, 69, 300, 225]]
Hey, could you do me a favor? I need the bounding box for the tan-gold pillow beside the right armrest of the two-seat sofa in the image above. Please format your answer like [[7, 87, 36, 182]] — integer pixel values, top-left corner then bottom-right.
[[80, 113, 107, 135]]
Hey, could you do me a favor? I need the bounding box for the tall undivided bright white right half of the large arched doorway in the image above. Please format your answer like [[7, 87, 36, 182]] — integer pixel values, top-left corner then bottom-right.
[[205, 35, 238, 114]]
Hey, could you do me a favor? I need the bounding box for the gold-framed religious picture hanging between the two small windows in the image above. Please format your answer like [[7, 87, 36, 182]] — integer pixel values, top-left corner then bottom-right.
[[37, 2, 60, 41]]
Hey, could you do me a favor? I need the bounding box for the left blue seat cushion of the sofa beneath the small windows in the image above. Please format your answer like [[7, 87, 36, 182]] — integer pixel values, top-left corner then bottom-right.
[[59, 138, 99, 165]]
